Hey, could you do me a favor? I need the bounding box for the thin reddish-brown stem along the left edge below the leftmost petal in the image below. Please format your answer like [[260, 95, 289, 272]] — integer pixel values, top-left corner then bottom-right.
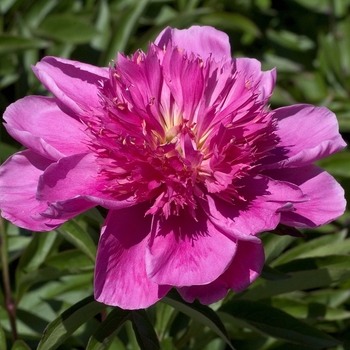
[[0, 216, 18, 342]]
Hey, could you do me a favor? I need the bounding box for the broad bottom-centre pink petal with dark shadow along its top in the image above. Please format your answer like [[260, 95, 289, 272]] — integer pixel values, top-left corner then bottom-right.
[[146, 209, 236, 287]]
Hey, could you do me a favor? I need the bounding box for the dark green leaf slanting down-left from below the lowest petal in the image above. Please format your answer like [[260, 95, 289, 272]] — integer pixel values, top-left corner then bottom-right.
[[37, 296, 106, 350]]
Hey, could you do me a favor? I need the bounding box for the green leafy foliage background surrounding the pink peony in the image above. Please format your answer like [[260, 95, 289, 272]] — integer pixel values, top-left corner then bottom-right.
[[0, 0, 350, 350]]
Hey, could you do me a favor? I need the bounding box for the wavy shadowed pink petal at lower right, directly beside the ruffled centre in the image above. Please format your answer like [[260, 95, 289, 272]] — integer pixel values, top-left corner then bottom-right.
[[200, 176, 308, 242]]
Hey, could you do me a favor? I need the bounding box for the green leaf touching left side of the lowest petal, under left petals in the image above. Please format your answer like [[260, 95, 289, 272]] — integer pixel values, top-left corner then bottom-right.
[[57, 219, 96, 262]]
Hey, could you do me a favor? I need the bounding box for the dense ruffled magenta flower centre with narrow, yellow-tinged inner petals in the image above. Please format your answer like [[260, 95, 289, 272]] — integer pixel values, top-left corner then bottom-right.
[[88, 47, 275, 218]]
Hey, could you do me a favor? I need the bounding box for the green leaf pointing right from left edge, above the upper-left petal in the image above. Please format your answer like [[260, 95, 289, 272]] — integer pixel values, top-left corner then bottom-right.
[[0, 34, 49, 55]]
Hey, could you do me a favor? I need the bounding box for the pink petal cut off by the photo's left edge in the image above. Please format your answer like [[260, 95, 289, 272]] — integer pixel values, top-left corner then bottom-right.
[[0, 150, 51, 231]]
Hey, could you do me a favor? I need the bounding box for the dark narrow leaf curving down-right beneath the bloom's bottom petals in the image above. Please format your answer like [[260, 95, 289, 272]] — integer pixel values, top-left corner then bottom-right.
[[161, 290, 234, 349]]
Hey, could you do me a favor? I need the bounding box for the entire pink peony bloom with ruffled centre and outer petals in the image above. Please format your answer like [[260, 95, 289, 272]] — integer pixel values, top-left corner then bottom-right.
[[0, 27, 345, 309]]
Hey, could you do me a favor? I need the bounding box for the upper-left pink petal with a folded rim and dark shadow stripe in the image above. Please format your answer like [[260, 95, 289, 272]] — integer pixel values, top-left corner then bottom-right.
[[33, 57, 108, 114]]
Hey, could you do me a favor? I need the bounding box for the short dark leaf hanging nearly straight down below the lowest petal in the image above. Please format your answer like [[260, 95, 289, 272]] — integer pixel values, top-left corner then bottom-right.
[[130, 310, 160, 350]]
